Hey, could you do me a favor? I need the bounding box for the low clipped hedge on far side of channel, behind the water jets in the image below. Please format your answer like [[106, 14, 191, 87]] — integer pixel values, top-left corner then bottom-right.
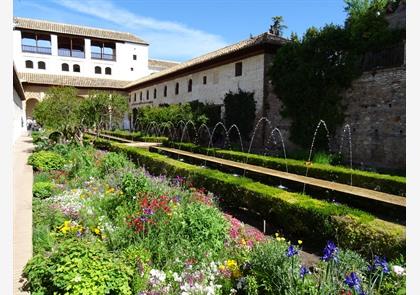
[[164, 141, 405, 196]]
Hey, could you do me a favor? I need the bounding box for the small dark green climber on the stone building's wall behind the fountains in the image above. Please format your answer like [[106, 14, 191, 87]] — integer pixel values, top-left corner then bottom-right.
[[223, 89, 256, 140]]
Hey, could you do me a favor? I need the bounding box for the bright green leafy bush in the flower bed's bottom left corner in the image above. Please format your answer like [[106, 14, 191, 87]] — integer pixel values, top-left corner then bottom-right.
[[24, 239, 133, 295]]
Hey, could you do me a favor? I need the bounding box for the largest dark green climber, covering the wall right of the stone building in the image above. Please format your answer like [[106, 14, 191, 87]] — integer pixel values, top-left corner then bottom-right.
[[270, 25, 358, 148]]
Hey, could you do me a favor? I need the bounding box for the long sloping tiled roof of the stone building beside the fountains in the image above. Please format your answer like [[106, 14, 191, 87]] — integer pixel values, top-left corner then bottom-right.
[[126, 33, 288, 88]]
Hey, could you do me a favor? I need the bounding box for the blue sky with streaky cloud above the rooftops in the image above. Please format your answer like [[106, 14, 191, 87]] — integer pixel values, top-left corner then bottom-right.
[[13, 0, 346, 61]]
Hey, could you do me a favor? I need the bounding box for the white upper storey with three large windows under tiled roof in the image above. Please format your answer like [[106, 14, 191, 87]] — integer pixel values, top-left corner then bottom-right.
[[13, 17, 149, 81]]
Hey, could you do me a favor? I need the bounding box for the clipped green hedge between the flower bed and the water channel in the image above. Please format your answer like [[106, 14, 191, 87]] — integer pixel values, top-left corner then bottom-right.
[[87, 136, 406, 258]]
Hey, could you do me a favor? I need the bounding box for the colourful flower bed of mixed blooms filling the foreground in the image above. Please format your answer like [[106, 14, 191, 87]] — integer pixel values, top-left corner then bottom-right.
[[24, 140, 405, 295]]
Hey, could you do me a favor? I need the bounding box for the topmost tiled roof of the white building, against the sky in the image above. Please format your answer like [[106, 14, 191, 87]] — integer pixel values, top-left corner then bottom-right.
[[13, 17, 148, 45]]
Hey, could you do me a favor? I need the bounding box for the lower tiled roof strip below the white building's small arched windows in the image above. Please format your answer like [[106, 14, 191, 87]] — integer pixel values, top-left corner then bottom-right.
[[18, 72, 129, 89]]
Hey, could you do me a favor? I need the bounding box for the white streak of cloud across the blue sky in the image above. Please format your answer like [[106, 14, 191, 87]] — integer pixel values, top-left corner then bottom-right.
[[54, 0, 227, 60]]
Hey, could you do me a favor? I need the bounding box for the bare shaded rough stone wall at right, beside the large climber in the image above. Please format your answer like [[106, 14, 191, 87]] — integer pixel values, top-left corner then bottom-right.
[[333, 67, 406, 170]]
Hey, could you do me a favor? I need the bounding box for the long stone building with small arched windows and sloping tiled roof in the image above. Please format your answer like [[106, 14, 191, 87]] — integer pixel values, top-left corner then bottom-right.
[[124, 33, 287, 130]]
